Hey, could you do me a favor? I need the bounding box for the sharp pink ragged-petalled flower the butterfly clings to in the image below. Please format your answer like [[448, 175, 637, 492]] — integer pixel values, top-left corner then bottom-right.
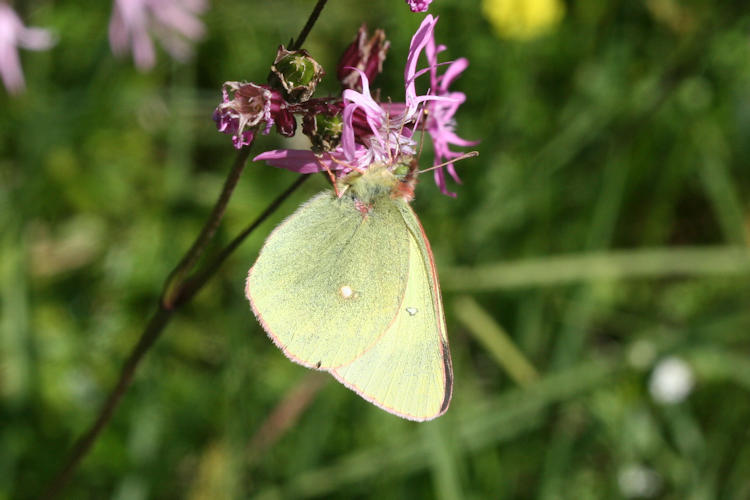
[[255, 15, 471, 196]]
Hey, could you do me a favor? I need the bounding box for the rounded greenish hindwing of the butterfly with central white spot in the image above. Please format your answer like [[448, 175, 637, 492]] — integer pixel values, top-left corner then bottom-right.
[[246, 192, 411, 370]]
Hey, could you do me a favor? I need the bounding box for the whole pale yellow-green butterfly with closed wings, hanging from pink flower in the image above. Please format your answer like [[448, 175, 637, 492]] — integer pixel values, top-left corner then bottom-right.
[[246, 165, 452, 420]]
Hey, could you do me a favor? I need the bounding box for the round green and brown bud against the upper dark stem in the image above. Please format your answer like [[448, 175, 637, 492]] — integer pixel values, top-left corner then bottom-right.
[[271, 45, 325, 102]]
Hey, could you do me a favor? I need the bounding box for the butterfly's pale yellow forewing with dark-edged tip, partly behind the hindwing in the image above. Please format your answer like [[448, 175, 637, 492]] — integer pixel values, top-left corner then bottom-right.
[[331, 202, 453, 421]]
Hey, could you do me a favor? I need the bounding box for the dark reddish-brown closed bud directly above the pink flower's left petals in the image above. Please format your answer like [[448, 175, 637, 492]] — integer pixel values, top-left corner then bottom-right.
[[336, 24, 391, 91]]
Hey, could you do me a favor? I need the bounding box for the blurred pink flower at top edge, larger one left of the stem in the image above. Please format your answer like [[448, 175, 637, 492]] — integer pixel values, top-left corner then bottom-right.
[[109, 0, 207, 70]]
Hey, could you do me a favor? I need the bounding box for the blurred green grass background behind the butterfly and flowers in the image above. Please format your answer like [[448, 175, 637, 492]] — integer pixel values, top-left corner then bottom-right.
[[0, 0, 750, 500]]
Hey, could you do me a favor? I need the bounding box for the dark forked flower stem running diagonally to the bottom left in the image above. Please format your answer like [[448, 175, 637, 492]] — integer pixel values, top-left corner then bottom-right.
[[41, 0, 327, 499]]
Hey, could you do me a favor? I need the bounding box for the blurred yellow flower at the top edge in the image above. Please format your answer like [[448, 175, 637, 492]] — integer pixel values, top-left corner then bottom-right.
[[482, 0, 565, 40]]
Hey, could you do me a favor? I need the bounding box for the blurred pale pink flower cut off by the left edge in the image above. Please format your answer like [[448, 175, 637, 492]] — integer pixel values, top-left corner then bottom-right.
[[0, 2, 55, 94]]
